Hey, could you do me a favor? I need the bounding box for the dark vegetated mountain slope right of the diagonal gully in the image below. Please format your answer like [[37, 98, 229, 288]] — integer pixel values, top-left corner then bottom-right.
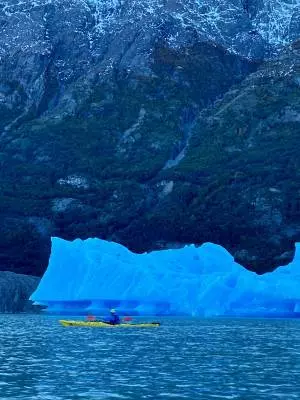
[[147, 44, 300, 272]]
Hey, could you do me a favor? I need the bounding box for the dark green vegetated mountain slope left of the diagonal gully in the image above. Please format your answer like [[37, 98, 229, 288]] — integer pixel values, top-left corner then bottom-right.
[[0, 42, 257, 275]]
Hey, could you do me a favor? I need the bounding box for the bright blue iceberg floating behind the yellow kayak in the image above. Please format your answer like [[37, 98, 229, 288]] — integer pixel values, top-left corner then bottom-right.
[[31, 238, 300, 317]]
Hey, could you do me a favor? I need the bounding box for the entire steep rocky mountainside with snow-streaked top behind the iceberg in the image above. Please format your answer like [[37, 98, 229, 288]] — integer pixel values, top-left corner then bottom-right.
[[0, 0, 300, 275]]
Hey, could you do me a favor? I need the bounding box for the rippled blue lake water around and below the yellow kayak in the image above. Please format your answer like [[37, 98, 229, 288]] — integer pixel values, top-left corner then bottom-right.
[[0, 315, 300, 400]]
